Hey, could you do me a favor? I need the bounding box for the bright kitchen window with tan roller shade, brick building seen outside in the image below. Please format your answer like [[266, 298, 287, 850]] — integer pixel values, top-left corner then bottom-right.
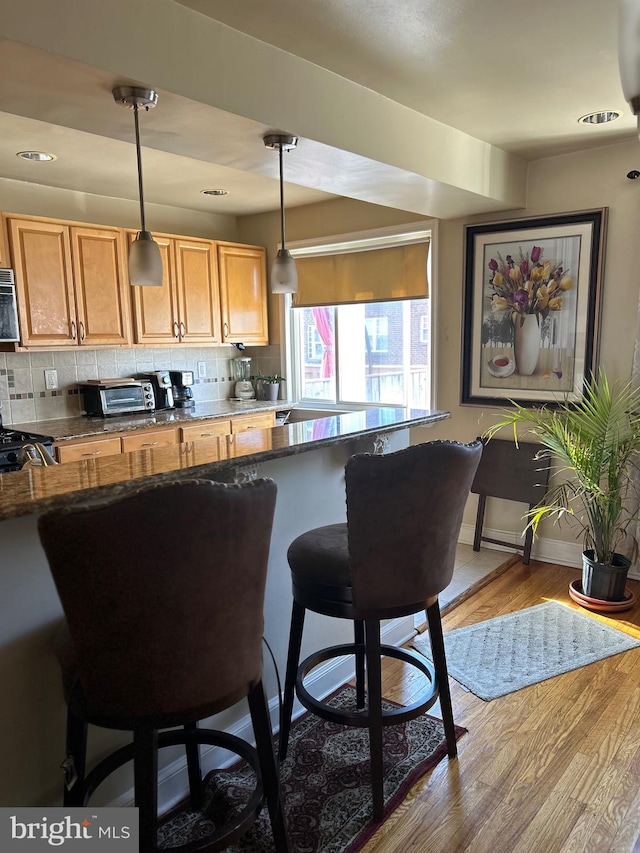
[[287, 224, 432, 409]]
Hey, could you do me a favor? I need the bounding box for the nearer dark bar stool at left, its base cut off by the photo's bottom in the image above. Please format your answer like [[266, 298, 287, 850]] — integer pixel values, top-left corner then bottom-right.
[[38, 479, 289, 853]]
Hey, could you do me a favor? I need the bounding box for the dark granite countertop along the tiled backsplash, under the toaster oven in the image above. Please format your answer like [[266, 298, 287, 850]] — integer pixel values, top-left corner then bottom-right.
[[10, 400, 296, 441]]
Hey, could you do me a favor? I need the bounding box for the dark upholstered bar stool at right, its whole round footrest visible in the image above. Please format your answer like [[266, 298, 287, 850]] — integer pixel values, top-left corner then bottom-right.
[[280, 441, 482, 820]]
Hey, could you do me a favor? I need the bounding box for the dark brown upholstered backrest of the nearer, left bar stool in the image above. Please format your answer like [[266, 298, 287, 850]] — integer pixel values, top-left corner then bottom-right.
[[38, 479, 277, 719]]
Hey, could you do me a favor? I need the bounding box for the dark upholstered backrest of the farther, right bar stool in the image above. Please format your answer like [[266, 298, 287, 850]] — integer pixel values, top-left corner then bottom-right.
[[345, 441, 482, 615]]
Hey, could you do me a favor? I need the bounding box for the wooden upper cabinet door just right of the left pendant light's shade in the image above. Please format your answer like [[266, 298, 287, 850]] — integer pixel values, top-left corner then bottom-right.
[[174, 238, 221, 344]]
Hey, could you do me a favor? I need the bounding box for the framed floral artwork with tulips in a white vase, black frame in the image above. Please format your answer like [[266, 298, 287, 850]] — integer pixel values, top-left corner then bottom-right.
[[461, 208, 607, 406]]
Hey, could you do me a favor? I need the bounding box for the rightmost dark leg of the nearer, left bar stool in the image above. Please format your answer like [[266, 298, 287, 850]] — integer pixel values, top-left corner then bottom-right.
[[248, 681, 289, 853]]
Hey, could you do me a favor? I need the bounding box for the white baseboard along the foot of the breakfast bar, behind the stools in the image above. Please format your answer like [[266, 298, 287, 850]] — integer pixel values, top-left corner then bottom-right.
[[108, 616, 416, 814]]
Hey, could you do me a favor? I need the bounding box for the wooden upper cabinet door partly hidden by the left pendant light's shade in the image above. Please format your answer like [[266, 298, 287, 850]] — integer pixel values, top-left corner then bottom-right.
[[127, 231, 180, 346]]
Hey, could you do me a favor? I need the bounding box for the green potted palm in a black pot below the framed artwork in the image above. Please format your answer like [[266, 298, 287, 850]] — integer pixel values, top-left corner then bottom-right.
[[486, 370, 640, 601]]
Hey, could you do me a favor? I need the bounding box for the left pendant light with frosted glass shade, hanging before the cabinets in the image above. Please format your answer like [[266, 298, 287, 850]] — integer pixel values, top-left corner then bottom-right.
[[113, 86, 163, 287]]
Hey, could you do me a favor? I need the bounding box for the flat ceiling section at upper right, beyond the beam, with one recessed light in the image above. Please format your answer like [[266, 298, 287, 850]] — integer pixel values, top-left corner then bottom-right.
[[178, 0, 635, 159]]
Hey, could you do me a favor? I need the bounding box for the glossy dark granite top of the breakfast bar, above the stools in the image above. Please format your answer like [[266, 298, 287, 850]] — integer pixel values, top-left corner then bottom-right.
[[0, 404, 450, 519]]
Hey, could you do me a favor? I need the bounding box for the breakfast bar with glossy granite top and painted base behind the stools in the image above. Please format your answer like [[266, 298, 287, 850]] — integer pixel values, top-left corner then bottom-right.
[[0, 407, 449, 810]]
